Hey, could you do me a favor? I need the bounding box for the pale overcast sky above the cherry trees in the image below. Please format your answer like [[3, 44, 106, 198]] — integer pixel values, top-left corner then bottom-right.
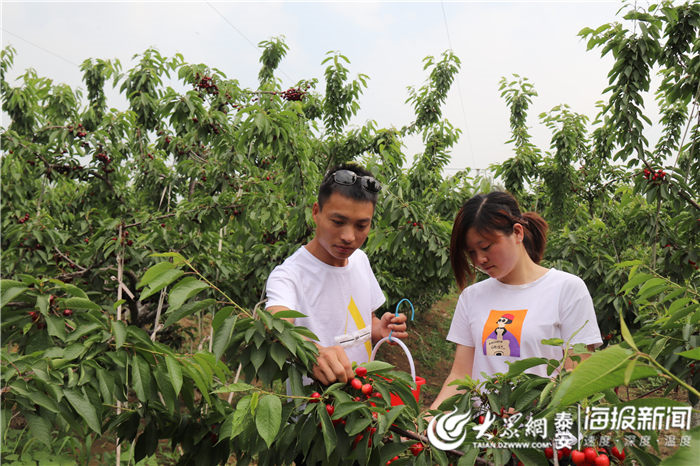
[[0, 1, 640, 173]]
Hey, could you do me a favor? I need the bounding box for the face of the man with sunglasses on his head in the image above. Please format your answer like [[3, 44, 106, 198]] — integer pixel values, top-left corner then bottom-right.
[[310, 193, 374, 267]]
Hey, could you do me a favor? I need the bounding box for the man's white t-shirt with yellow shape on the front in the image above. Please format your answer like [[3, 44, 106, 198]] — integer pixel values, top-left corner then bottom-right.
[[266, 246, 386, 363]]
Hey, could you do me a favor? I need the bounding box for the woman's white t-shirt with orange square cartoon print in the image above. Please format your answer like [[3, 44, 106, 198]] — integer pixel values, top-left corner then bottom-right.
[[447, 269, 603, 380]]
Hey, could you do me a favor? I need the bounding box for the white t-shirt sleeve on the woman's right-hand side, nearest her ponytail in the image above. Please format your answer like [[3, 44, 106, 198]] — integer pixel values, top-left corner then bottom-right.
[[560, 276, 603, 347]]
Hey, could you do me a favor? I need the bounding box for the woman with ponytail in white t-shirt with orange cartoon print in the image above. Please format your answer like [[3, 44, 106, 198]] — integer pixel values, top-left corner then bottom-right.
[[431, 192, 602, 408]]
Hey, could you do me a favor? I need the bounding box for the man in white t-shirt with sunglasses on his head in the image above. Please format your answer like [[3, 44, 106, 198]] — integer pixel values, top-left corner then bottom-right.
[[266, 164, 407, 384]]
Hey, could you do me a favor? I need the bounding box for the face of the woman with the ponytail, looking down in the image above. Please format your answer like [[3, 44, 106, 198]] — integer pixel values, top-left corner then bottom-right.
[[467, 223, 523, 283]]
